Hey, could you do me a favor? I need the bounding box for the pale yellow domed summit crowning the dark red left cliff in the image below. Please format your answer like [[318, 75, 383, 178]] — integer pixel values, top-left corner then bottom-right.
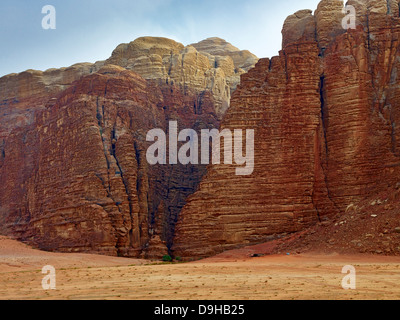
[[106, 37, 258, 118]]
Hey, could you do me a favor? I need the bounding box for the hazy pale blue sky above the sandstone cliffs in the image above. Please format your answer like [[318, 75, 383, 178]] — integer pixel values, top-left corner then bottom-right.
[[0, 0, 319, 76]]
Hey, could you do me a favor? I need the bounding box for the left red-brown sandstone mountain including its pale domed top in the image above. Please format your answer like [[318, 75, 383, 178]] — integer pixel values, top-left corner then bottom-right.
[[0, 38, 256, 258]]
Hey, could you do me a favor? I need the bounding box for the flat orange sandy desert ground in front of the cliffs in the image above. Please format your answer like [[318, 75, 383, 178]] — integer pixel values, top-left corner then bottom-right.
[[0, 237, 400, 300]]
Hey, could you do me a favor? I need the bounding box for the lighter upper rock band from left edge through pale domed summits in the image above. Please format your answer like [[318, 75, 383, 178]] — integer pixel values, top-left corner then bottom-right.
[[0, 37, 258, 143]]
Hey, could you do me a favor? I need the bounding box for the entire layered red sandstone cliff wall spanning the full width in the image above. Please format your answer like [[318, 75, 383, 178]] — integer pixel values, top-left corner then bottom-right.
[[0, 0, 400, 258]]
